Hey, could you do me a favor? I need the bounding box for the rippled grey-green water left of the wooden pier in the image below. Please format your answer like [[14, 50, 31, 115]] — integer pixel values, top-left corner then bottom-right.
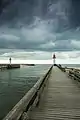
[[0, 65, 51, 119]]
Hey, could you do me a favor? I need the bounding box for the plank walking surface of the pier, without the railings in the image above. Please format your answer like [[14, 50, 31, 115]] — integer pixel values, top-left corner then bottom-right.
[[29, 67, 80, 120]]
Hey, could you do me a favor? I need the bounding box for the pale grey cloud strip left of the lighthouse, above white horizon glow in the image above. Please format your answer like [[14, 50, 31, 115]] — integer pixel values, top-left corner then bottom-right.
[[0, 49, 52, 60]]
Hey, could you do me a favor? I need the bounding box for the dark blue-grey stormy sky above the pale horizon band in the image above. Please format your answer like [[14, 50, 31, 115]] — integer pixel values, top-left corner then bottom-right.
[[0, 0, 80, 62]]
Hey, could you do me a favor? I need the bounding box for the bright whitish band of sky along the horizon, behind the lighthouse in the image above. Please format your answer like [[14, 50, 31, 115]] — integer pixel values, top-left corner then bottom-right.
[[0, 49, 80, 64]]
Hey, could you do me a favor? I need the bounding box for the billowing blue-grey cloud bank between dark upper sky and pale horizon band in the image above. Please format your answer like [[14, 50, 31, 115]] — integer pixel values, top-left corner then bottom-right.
[[0, 20, 80, 51]]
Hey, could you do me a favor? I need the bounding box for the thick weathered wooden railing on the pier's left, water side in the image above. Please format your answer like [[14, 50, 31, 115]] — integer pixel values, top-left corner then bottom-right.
[[3, 66, 53, 120]]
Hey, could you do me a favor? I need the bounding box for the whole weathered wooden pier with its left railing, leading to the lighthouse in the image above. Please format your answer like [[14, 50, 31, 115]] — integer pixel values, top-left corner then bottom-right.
[[3, 66, 80, 120]]
